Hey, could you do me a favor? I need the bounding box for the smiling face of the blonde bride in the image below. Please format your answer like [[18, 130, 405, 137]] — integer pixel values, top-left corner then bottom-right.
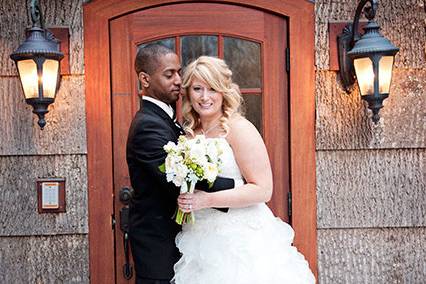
[[189, 79, 223, 118]]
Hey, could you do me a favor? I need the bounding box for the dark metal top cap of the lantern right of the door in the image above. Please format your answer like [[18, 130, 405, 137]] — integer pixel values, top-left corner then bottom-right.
[[348, 20, 399, 59]]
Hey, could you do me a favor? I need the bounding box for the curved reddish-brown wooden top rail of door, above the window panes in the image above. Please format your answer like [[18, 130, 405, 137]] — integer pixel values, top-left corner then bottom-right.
[[126, 3, 265, 40]]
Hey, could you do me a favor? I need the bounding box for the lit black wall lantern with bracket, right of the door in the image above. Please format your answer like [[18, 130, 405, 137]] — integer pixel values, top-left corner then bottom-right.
[[337, 0, 399, 124]]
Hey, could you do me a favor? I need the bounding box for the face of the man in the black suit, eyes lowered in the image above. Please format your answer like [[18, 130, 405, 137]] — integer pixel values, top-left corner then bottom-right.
[[148, 53, 182, 104]]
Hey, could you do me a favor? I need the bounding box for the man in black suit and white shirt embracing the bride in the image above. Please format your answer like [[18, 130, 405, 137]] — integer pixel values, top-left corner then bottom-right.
[[126, 44, 234, 284]]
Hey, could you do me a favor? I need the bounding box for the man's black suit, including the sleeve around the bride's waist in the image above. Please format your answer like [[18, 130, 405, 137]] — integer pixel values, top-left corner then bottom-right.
[[126, 100, 234, 279]]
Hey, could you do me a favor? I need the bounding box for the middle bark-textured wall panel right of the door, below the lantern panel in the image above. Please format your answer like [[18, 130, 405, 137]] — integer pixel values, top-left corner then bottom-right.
[[316, 149, 426, 229]]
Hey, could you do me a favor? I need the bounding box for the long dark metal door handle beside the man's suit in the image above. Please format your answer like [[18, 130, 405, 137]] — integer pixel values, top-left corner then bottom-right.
[[119, 187, 133, 280]]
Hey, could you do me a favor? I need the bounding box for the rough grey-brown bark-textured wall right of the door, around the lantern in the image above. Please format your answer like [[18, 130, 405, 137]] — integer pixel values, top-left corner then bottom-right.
[[315, 0, 426, 284]]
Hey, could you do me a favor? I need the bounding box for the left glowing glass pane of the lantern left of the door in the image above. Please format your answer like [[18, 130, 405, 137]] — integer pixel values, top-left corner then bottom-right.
[[17, 59, 38, 99]]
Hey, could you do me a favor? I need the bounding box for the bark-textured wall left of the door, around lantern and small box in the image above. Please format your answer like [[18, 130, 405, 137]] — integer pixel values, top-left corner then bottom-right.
[[0, 0, 89, 283]]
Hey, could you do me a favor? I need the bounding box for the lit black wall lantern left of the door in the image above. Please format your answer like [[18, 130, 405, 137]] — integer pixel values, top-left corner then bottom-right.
[[10, 0, 64, 129]]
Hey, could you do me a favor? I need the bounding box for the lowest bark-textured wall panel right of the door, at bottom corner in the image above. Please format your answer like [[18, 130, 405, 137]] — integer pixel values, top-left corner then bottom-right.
[[318, 228, 426, 284]]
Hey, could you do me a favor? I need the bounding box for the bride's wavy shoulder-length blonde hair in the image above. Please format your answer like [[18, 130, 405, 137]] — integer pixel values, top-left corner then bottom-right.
[[182, 56, 243, 136]]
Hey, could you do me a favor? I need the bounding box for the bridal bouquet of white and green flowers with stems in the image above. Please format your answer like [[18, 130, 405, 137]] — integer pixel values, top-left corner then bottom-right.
[[160, 135, 223, 224]]
